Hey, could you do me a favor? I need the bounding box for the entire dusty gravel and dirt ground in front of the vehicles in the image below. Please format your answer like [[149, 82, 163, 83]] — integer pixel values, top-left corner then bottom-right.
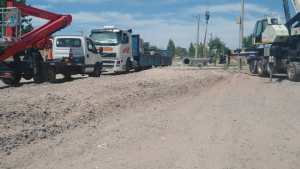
[[0, 68, 300, 169]]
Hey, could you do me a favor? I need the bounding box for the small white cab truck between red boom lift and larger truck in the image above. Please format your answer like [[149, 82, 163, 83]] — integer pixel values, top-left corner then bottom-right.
[[46, 36, 103, 82]]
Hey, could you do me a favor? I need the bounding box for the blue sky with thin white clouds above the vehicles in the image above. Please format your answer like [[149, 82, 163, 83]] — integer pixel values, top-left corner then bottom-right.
[[28, 0, 282, 48]]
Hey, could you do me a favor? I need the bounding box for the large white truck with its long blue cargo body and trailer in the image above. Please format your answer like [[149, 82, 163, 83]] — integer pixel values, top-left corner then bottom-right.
[[90, 26, 172, 72]]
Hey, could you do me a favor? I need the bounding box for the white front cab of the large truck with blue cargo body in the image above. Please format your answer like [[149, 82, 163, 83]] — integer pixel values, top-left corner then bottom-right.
[[90, 26, 133, 72]]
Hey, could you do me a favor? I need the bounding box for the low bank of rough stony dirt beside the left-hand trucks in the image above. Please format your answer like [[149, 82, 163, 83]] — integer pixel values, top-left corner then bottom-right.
[[0, 68, 227, 154]]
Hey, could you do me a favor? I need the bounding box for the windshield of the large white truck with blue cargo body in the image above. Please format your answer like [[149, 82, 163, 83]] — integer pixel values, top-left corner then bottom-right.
[[91, 32, 120, 45]]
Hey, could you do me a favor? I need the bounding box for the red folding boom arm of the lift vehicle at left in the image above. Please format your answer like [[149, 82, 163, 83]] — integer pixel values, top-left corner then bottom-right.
[[0, 0, 72, 61]]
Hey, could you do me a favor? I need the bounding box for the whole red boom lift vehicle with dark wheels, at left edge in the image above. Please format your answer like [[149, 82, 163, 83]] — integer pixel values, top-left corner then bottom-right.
[[0, 0, 72, 85]]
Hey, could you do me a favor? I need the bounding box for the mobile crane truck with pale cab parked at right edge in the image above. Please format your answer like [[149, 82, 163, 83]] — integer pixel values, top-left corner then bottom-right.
[[245, 0, 300, 81]]
